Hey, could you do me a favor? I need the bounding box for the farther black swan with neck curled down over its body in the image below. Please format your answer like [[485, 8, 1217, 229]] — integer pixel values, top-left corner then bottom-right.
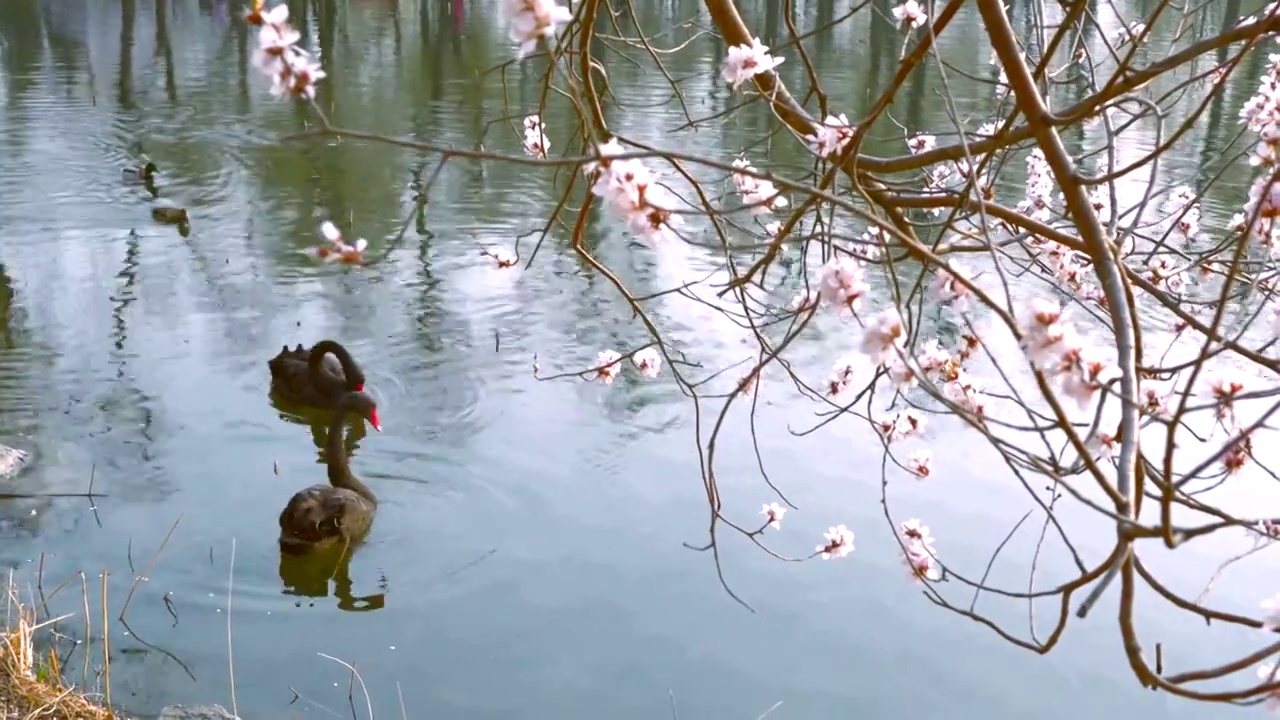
[[266, 340, 365, 407]]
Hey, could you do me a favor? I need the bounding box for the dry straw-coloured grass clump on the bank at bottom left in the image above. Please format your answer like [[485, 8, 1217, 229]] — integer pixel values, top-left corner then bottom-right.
[[0, 579, 116, 720]]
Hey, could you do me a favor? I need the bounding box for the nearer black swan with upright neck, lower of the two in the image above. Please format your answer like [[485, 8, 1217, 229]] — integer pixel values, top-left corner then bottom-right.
[[280, 392, 383, 555]]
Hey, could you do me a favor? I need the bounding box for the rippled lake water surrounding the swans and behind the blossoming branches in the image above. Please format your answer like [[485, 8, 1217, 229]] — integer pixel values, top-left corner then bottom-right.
[[0, 0, 1276, 720]]
